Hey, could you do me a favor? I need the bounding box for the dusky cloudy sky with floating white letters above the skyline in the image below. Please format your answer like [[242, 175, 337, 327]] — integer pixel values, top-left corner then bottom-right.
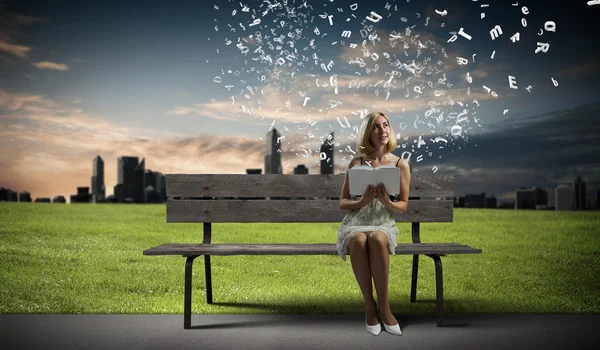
[[0, 0, 600, 201]]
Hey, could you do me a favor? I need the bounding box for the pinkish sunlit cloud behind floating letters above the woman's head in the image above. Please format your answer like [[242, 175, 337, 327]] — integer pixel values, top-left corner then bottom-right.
[[186, 20, 508, 135]]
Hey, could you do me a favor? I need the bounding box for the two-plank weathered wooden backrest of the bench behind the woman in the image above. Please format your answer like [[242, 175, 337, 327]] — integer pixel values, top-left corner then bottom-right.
[[166, 174, 454, 223]]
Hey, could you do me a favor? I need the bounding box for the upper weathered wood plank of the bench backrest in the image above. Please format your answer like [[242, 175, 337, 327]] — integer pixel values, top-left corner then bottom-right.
[[166, 174, 454, 199]]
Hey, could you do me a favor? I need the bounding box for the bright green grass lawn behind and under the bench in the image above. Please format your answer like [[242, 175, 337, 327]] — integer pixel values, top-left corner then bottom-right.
[[0, 203, 600, 315]]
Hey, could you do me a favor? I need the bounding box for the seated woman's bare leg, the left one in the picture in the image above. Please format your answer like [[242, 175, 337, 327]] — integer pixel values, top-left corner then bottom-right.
[[348, 232, 379, 326]]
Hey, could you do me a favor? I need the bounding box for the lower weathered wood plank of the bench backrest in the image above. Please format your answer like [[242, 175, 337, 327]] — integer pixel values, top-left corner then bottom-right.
[[167, 200, 454, 222]]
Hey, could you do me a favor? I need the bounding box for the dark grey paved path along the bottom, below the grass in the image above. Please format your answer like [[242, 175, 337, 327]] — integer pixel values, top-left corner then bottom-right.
[[0, 314, 600, 350]]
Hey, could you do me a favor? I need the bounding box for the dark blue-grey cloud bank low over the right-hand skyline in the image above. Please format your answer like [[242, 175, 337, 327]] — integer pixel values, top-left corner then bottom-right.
[[411, 103, 600, 198]]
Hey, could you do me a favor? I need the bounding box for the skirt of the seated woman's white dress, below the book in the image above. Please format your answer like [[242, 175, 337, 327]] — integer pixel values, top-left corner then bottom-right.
[[337, 196, 398, 261]]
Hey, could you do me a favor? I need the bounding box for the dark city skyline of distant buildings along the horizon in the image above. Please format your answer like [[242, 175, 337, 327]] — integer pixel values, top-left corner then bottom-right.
[[3, 128, 600, 210]]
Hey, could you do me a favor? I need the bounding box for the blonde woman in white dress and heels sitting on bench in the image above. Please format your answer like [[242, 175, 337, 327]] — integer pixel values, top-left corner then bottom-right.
[[337, 112, 410, 335]]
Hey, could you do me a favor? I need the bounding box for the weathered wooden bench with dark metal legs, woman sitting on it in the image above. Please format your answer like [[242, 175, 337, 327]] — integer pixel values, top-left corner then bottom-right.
[[144, 174, 481, 329]]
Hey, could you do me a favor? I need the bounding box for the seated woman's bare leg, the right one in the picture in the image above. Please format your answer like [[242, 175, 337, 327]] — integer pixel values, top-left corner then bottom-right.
[[367, 231, 398, 326]]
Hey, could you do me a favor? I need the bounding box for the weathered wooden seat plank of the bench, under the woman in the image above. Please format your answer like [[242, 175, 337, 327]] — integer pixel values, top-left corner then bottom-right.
[[144, 243, 481, 256]]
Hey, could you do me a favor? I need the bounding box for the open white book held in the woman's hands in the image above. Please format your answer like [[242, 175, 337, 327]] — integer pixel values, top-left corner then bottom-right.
[[348, 164, 400, 196]]
